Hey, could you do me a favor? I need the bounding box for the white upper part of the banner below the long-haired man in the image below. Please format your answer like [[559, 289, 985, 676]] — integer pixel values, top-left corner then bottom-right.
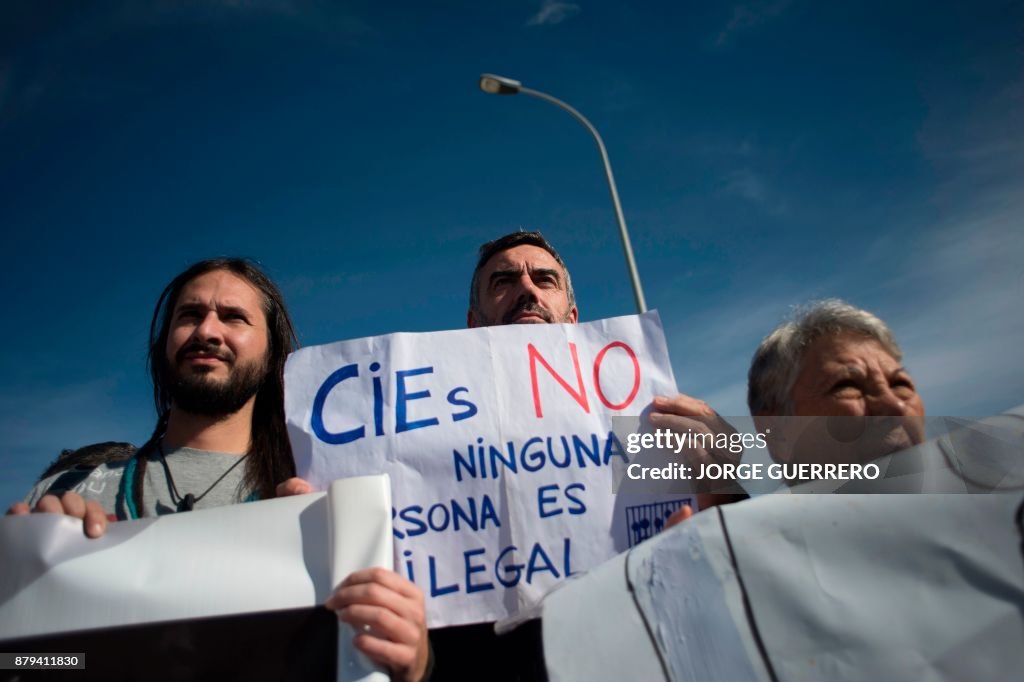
[[0, 476, 392, 682]]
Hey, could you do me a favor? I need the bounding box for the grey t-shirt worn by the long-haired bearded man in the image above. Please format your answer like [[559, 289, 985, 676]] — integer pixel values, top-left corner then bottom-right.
[[25, 447, 250, 518]]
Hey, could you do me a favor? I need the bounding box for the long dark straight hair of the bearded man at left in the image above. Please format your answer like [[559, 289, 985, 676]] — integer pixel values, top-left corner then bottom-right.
[[132, 258, 299, 513]]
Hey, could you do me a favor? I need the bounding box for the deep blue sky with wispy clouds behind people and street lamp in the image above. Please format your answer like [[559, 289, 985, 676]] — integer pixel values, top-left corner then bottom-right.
[[0, 0, 1024, 505]]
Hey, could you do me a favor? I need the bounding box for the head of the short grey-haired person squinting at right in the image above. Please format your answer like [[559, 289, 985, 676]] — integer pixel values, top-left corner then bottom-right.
[[746, 299, 925, 473]]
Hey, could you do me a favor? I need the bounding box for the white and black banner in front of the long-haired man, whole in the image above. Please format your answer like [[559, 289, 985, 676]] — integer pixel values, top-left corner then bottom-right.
[[0, 476, 391, 682]]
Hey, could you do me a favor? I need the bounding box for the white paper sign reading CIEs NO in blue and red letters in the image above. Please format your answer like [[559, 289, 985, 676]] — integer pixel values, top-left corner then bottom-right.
[[285, 312, 682, 627]]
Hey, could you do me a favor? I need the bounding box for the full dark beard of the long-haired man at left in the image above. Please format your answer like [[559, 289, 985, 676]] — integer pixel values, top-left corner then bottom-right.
[[168, 344, 267, 417]]
